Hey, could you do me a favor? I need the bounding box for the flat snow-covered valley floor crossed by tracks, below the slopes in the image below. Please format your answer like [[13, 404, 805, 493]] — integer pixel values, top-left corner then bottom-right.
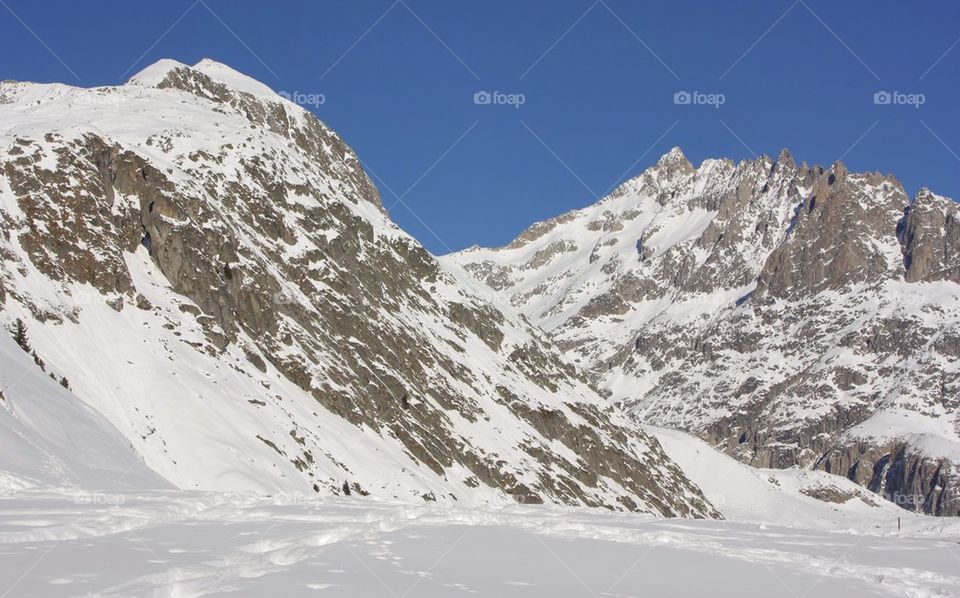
[[0, 491, 960, 598]]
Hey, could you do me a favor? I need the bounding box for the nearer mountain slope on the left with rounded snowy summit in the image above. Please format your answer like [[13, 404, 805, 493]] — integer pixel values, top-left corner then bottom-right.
[[0, 61, 716, 516]]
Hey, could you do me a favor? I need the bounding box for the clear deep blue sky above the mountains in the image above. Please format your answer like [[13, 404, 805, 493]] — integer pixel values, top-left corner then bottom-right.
[[0, 0, 960, 253]]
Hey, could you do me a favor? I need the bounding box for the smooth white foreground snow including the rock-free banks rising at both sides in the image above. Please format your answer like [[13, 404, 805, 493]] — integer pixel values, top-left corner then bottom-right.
[[0, 350, 960, 598]]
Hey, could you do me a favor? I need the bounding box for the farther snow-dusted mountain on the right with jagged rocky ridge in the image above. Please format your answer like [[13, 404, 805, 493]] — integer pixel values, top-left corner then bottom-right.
[[444, 148, 960, 515]]
